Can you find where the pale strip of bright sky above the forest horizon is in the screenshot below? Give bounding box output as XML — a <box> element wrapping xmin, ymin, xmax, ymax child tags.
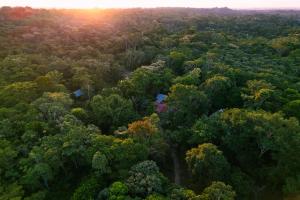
<box><xmin>0</xmin><ymin>0</ymin><xmax>300</xmax><ymax>9</ymax></box>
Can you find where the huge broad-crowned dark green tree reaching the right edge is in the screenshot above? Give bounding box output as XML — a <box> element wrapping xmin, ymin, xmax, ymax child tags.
<box><xmin>210</xmin><ymin>109</ymin><xmax>300</xmax><ymax>190</ymax></box>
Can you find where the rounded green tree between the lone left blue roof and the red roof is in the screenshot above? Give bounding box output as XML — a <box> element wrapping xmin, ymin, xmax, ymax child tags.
<box><xmin>91</xmin><ymin>94</ymin><xmax>136</xmax><ymax>130</ymax></box>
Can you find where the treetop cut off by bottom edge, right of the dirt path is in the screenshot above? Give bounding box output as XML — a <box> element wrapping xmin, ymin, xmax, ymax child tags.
<box><xmin>196</xmin><ymin>182</ymin><xmax>236</xmax><ymax>200</ymax></box>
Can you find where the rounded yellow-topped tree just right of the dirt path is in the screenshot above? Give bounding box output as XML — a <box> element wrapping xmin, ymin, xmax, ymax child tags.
<box><xmin>186</xmin><ymin>143</ymin><xmax>230</xmax><ymax>184</ymax></box>
